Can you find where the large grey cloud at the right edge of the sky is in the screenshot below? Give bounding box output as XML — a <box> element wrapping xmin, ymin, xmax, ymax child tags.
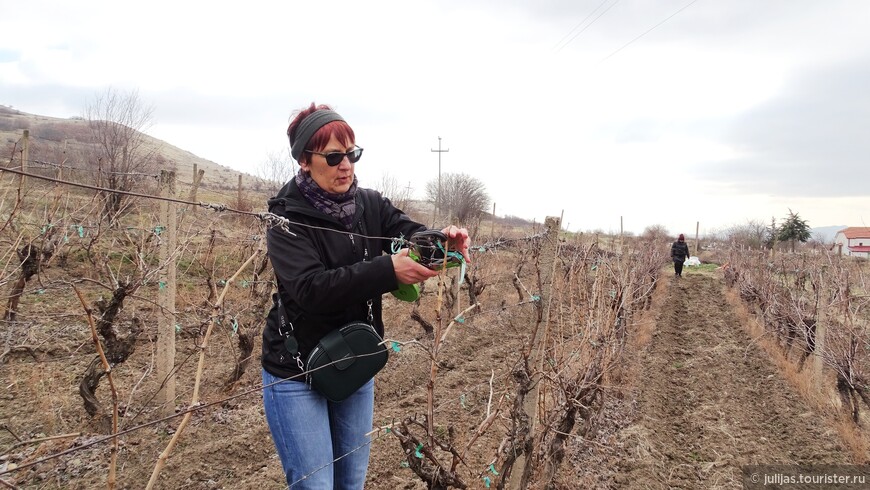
<box><xmin>696</xmin><ymin>56</ymin><xmax>870</xmax><ymax>197</ymax></box>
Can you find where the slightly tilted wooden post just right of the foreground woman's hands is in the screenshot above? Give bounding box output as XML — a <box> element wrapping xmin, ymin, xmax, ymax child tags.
<box><xmin>507</xmin><ymin>216</ymin><xmax>561</xmax><ymax>488</ymax></box>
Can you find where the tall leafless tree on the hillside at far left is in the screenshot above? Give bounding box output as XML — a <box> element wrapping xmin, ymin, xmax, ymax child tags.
<box><xmin>84</xmin><ymin>88</ymin><xmax>159</xmax><ymax>224</ymax></box>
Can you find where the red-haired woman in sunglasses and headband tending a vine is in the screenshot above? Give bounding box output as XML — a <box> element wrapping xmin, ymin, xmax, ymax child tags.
<box><xmin>262</xmin><ymin>103</ymin><xmax>469</xmax><ymax>489</ymax></box>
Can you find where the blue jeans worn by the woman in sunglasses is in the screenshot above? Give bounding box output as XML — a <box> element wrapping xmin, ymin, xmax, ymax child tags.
<box><xmin>263</xmin><ymin>369</ymin><xmax>375</xmax><ymax>490</ymax></box>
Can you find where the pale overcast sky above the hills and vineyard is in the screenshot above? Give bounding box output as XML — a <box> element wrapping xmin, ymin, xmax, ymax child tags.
<box><xmin>0</xmin><ymin>0</ymin><xmax>870</xmax><ymax>235</ymax></box>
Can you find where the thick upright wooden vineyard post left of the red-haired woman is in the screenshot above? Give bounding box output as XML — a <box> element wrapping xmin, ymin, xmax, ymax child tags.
<box><xmin>157</xmin><ymin>170</ymin><xmax>177</xmax><ymax>416</ymax></box>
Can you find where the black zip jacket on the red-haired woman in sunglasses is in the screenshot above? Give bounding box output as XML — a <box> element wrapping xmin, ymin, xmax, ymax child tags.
<box><xmin>262</xmin><ymin>179</ymin><xmax>426</xmax><ymax>381</ymax></box>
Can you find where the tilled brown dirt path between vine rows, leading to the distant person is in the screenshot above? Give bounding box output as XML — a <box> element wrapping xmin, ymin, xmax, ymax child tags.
<box><xmin>615</xmin><ymin>274</ymin><xmax>849</xmax><ymax>489</ymax></box>
